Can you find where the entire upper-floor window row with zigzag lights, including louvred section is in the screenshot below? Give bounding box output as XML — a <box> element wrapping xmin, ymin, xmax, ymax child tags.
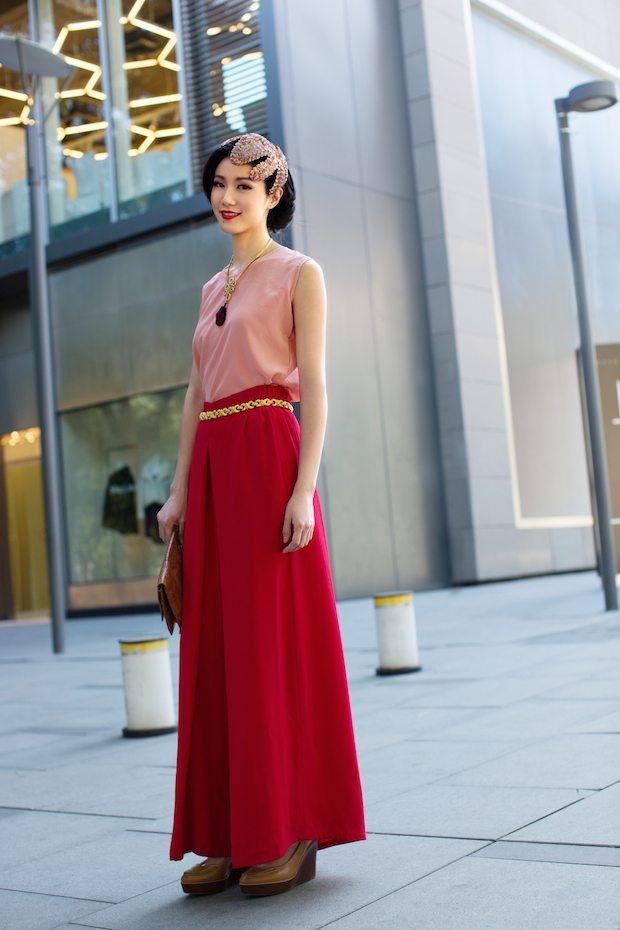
<box><xmin>0</xmin><ymin>0</ymin><xmax>268</xmax><ymax>257</ymax></box>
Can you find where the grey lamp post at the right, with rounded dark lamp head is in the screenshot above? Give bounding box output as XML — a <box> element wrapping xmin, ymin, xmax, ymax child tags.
<box><xmin>555</xmin><ymin>81</ymin><xmax>618</xmax><ymax>610</ymax></box>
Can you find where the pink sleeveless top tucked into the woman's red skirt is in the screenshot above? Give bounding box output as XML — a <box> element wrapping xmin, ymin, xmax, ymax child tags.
<box><xmin>192</xmin><ymin>246</ymin><xmax>308</xmax><ymax>401</ymax></box>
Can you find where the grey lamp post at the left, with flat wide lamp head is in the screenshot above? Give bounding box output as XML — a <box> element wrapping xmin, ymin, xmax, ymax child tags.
<box><xmin>0</xmin><ymin>35</ymin><xmax>73</xmax><ymax>652</ymax></box>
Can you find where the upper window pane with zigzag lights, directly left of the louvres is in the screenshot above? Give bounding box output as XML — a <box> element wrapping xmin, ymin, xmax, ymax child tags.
<box><xmin>106</xmin><ymin>0</ymin><xmax>188</xmax><ymax>217</ymax></box>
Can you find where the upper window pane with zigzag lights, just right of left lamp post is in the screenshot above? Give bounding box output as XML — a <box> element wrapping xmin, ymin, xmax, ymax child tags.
<box><xmin>38</xmin><ymin>0</ymin><xmax>110</xmax><ymax>239</ymax></box>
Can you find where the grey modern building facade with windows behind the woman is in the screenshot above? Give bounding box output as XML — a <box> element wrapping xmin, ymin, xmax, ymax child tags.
<box><xmin>0</xmin><ymin>0</ymin><xmax>620</xmax><ymax>616</ymax></box>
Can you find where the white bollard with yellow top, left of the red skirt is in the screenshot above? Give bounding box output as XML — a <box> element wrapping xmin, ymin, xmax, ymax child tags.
<box><xmin>119</xmin><ymin>637</ymin><xmax>177</xmax><ymax>736</ymax></box>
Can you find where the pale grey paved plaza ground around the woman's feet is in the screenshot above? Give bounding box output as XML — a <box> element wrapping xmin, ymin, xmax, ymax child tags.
<box><xmin>0</xmin><ymin>572</ymin><xmax>620</xmax><ymax>930</ymax></box>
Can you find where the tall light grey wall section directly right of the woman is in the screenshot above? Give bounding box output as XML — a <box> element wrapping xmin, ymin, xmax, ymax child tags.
<box><xmin>275</xmin><ymin>0</ymin><xmax>449</xmax><ymax>597</ymax></box>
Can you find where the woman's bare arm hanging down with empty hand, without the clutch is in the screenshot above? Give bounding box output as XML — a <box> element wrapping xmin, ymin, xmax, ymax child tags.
<box><xmin>282</xmin><ymin>260</ymin><xmax>327</xmax><ymax>552</ymax></box>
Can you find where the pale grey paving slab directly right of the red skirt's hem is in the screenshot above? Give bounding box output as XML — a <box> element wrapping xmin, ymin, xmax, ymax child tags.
<box><xmin>366</xmin><ymin>782</ymin><xmax>583</xmax><ymax>840</ymax></box>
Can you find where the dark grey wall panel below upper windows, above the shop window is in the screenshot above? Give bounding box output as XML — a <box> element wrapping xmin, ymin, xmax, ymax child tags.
<box><xmin>51</xmin><ymin>223</ymin><xmax>230</xmax><ymax>410</ymax></box>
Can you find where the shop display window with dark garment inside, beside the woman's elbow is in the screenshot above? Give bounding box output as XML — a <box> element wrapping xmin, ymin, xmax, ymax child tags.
<box><xmin>61</xmin><ymin>388</ymin><xmax>185</xmax><ymax>585</ymax></box>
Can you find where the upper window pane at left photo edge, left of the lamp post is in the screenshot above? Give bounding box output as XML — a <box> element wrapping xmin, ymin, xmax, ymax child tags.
<box><xmin>0</xmin><ymin>2</ymin><xmax>30</xmax><ymax>257</ymax></box>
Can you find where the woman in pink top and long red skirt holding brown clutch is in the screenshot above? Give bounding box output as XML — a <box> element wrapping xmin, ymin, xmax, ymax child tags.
<box><xmin>158</xmin><ymin>133</ymin><xmax>366</xmax><ymax>895</ymax></box>
